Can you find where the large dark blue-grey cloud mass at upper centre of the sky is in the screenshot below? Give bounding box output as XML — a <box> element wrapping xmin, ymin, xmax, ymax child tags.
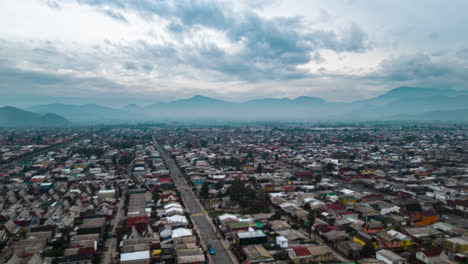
<box><xmin>75</xmin><ymin>0</ymin><xmax>369</xmax><ymax>81</ymax></box>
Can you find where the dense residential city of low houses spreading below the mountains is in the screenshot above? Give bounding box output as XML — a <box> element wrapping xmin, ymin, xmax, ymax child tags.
<box><xmin>0</xmin><ymin>123</ymin><xmax>468</xmax><ymax>264</ymax></box>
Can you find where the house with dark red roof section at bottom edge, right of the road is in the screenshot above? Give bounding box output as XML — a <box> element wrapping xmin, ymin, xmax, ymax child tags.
<box><xmin>287</xmin><ymin>246</ymin><xmax>334</xmax><ymax>264</ymax></box>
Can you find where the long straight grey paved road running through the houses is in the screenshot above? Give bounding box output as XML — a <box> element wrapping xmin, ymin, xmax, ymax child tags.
<box><xmin>153</xmin><ymin>138</ymin><xmax>232</xmax><ymax>264</ymax></box>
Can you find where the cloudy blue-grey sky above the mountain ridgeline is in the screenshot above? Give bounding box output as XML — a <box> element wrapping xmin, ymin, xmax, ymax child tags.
<box><xmin>0</xmin><ymin>0</ymin><xmax>468</xmax><ymax>106</ymax></box>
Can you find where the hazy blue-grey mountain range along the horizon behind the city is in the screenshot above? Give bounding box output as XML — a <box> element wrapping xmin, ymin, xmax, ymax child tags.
<box><xmin>0</xmin><ymin>87</ymin><xmax>468</xmax><ymax>126</ymax></box>
